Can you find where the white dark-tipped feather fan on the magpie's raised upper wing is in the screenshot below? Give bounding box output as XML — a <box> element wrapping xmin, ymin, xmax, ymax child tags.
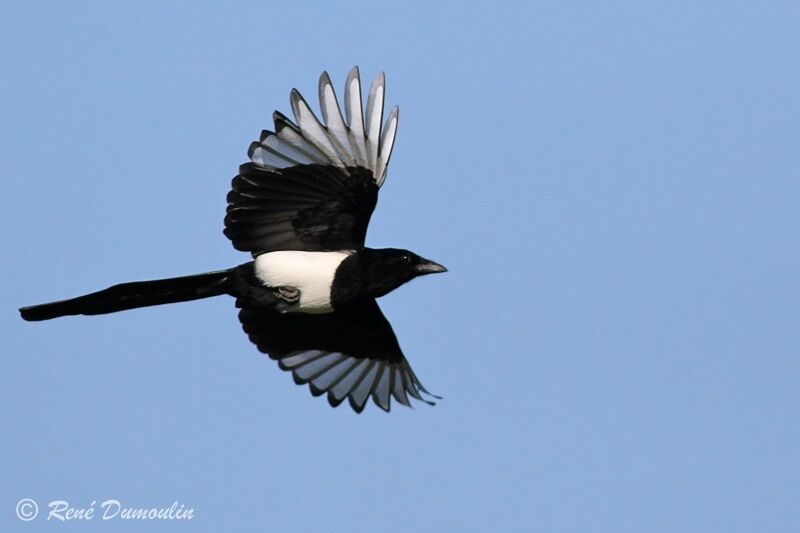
<box><xmin>248</xmin><ymin>67</ymin><xmax>399</xmax><ymax>187</ymax></box>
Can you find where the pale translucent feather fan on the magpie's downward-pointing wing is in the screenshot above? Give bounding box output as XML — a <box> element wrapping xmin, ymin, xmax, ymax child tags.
<box><xmin>278</xmin><ymin>350</ymin><xmax>440</xmax><ymax>413</ymax></box>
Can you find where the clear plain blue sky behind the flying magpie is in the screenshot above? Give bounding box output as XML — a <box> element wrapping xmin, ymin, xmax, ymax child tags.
<box><xmin>0</xmin><ymin>1</ymin><xmax>800</xmax><ymax>533</ymax></box>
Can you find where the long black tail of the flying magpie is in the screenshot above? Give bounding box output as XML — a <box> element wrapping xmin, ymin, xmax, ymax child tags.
<box><xmin>19</xmin><ymin>269</ymin><xmax>234</xmax><ymax>320</ymax></box>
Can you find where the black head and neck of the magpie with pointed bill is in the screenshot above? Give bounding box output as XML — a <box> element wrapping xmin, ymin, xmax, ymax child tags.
<box><xmin>357</xmin><ymin>248</ymin><xmax>447</xmax><ymax>298</ymax></box>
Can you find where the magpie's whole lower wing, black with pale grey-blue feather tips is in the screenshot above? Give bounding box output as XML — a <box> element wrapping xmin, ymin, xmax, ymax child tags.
<box><xmin>237</xmin><ymin>300</ymin><xmax>437</xmax><ymax>413</ymax></box>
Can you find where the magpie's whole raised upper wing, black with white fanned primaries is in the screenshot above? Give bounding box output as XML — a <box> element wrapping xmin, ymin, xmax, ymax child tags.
<box><xmin>225</xmin><ymin>68</ymin><xmax>398</xmax><ymax>255</ymax></box>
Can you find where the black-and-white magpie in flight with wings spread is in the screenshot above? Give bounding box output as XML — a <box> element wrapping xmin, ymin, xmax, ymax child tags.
<box><xmin>20</xmin><ymin>67</ymin><xmax>447</xmax><ymax>413</ymax></box>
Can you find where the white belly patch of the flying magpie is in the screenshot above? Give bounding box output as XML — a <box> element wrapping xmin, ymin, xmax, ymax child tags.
<box><xmin>255</xmin><ymin>250</ymin><xmax>350</xmax><ymax>313</ymax></box>
